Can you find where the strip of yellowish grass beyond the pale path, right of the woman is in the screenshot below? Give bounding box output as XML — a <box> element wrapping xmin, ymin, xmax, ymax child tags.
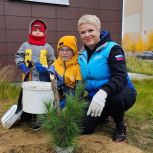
<box><xmin>126</xmin><ymin>57</ymin><xmax>153</xmax><ymax>75</ymax></box>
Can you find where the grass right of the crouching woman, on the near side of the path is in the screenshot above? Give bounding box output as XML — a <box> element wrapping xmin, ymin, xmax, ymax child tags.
<box><xmin>126</xmin><ymin>79</ymin><xmax>153</xmax><ymax>153</ymax></box>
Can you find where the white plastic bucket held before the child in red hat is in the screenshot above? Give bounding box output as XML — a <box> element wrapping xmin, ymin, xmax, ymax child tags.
<box><xmin>22</xmin><ymin>81</ymin><xmax>54</xmax><ymax>114</ymax></box>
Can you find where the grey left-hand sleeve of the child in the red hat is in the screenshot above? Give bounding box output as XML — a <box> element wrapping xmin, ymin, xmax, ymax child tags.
<box><xmin>15</xmin><ymin>43</ymin><xmax>25</xmax><ymax>66</ymax></box>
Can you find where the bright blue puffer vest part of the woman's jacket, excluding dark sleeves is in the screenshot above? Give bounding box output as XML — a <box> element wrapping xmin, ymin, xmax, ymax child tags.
<box><xmin>78</xmin><ymin>41</ymin><xmax>117</xmax><ymax>91</ymax></box>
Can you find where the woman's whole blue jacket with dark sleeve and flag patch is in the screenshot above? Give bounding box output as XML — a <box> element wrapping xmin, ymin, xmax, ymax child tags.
<box><xmin>78</xmin><ymin>29</ymin><xmax>135</xmax><ymax>96</ymax></box>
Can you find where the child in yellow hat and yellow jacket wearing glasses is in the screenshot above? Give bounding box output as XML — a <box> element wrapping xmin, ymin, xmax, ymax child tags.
<box><xmin>36</xmin><ymin>36</ymin><xmax>82</xmax><ymax>108</ymax></box>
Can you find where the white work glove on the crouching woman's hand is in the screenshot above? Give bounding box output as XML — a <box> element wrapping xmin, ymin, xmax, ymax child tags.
<box><xmin>87</xmin><ymin>89</ymin><xmax>107</xmax><ymax>117</ymax></box>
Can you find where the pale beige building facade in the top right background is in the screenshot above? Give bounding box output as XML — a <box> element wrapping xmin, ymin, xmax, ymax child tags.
<box><xmin>123</xmin><ymin>0</ymin><xmax>153</xmax><ymax>39</ymax></box>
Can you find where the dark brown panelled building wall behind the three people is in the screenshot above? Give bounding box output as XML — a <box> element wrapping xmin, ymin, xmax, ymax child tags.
<box><xmin>0</xmin><ymin>0</ymin><xmax>123</xmax><ymax>80</ymax></box>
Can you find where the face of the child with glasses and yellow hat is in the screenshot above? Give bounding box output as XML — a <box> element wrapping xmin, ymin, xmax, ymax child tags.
<box><xmin>58</xmin><ymin>46</ymin><xmax>74</xmax><ymax>61</ymax></box>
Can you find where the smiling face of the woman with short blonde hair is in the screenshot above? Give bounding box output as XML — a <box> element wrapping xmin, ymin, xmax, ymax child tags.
<box><xmin>79</xmin><ymin>24</ymin><xmax>100</xmax><ymax>49</ymax></box>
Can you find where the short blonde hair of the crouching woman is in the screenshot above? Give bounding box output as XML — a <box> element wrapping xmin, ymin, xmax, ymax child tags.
<box><xmin>78</xmin><ymin>14</ymin><xmax>101</xmax><ymax>30</ymax></box>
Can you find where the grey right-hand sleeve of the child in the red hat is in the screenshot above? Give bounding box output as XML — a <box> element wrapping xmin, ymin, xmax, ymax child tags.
<box><xmin>47</xmin><ymin>45</ymin><xmax>55</xmax><ymax>65</ymax></box>
